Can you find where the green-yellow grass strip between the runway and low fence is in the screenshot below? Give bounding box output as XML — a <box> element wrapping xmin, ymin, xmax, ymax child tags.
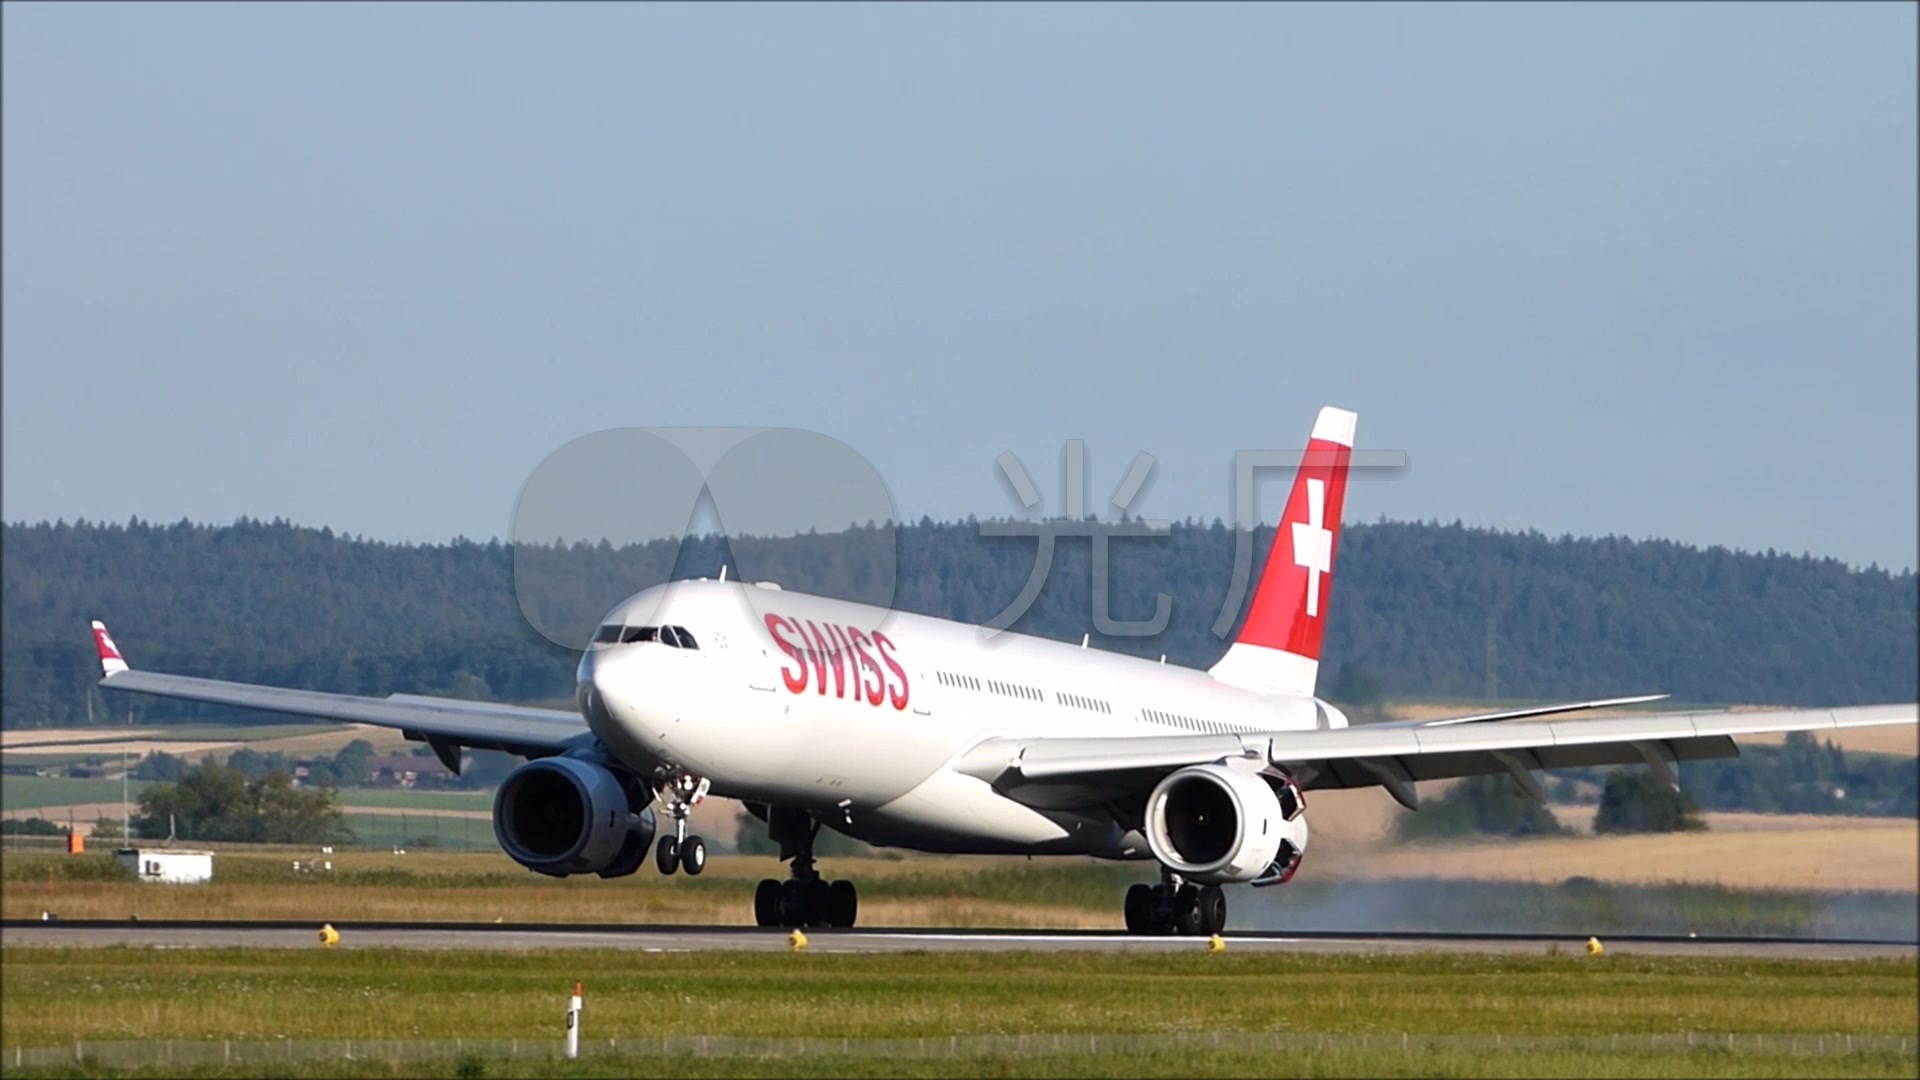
<box><xmin>0</xmin><ymin>945</ymin><xmax>1920</xmax><ymax>1076</ymax></box>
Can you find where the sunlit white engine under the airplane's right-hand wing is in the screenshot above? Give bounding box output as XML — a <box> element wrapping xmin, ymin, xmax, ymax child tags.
<box><xmin>1146</xmin><ymin>765</ymin><xmax>1308</xmax><ymax>884</ymax></box>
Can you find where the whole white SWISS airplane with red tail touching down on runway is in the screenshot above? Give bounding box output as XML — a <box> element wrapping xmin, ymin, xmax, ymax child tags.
<box><xmin>92</xmin><ymin>405</ymin><xmax>1916</xmax><ymax>936</ymax></box>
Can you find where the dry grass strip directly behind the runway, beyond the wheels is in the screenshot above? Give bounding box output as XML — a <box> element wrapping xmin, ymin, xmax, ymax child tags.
<box><xmin>0</xmin><ymin>849</ymin><xmax>1920</xmax><ymax>940</ymax></box>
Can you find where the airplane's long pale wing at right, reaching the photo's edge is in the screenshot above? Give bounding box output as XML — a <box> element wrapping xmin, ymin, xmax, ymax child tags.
<box><xmin>956</xmin><ymin>705</ymin><xmax>1920</xmax><ymax>809</ymax></box>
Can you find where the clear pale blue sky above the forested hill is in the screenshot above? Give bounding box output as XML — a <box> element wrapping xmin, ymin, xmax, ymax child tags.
<box><xmin>0</xmin><ymin>4</ymin><xmax>1920</xmax><ymax>567</ymax></box>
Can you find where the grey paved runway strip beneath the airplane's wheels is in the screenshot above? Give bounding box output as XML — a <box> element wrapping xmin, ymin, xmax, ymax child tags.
<box><xmin>0</xmin><ymin>919</ymin><xmax>1920</xmax><ymax>959</ymax></box>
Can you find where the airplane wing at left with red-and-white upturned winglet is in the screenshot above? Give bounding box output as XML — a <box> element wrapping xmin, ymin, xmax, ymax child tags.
<box><xmin>94</xmin><ymin>623</ymin><xmax>593</xmax><ymax>760</ymax></box>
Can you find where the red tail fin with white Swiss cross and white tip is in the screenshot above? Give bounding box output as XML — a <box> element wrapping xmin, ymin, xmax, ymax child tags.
<box><xmin>1213</xmin><ymin>405</ymin><xmax>1359</xmax><ymax>694</ymax></box>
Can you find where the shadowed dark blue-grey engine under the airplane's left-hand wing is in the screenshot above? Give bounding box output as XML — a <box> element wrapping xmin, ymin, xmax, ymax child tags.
<box><xmin>493</xmin><ymin>757</ymin><xmax>655</xmax><ymax>878</ymax></box>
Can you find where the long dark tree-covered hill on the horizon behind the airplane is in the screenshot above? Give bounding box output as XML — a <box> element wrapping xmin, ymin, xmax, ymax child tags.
<box><xmin>0</xmin><ymin>519</ymin><xmax>1920</xmax><ymax>726</ymax></box>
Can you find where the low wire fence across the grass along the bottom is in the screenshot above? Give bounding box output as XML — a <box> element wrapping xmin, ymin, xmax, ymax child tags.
<box><xmin>0</xmin><ymin>1032</ymin><xmax>1920</xmax><ymax>1070</ymax></box>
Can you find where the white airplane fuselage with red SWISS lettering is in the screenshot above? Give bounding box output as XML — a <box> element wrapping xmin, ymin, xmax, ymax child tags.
<box><xmin>578</xmin><ymin>580</ymin><xmax>1346</xmax><ymax>859</ymax></box>
